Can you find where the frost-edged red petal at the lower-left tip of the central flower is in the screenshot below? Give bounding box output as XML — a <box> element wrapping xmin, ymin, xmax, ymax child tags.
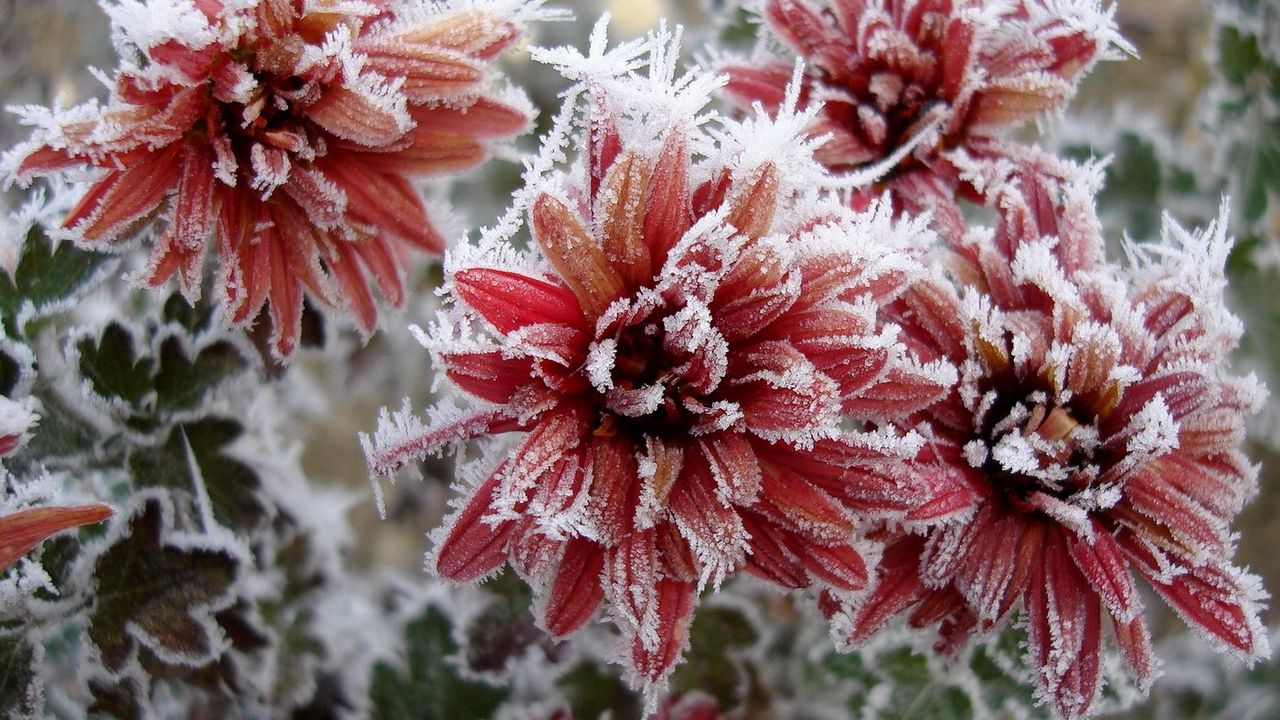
<box><xmin>435</xmin><ymin>465</ymin><xmax>516</xmax><ymax>583</ymax></box>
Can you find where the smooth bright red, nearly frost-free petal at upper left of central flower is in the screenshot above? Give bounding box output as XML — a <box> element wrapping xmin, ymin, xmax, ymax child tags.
<box><xmin>453</xmin><ymin>268</ymin><xmax>582</xmax><ymax>334</ymax></box>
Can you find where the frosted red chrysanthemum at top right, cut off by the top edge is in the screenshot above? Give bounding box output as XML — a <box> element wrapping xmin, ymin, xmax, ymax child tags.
<box><xmin>724</xmin><ymin>0</ymin><xmax>1128</xmax><ymax>229</ymax></box>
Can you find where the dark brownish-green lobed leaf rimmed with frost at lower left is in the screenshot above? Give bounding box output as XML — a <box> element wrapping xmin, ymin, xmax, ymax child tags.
<box><xmin>88</xmin><ymin>500</ymin><xmax>238</xmax><ymax>671</ymax></box>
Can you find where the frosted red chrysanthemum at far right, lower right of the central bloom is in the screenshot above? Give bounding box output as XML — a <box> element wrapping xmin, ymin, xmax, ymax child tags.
<box><xmin>828</xmin><ymin>166</ymin><xmax>1268</xmax><ymax>717</ymax></box>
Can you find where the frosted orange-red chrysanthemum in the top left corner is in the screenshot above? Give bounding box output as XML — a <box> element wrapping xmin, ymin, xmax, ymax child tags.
<box><xmin>5</xmin><ymin>0</ymin><xmax>537</xmax><ymax>356</ymax></box>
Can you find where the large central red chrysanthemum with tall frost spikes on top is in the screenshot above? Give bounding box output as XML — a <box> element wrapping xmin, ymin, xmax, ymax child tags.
<box><xmin>366</xmin><ymin>25</ymin><xmax>954</xmax><ymax>703</ymax></box>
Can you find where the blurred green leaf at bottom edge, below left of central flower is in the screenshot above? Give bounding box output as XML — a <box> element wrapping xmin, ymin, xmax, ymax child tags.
<box><xmin>370</xmin><ymin>606</ymin><xmax>509</xmax><ymax>720</ymax></box>
